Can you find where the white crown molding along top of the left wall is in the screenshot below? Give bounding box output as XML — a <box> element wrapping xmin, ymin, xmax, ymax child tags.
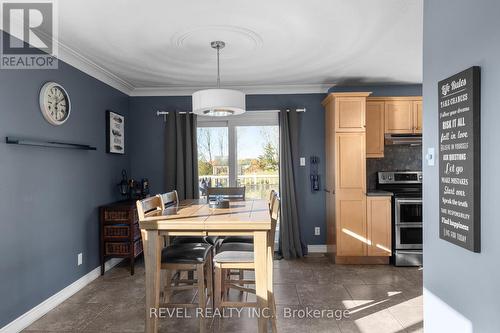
<box><xmin>57</xmin><ymin>42</ymin><xmax>134</xmax><ymax>96</ymax></box>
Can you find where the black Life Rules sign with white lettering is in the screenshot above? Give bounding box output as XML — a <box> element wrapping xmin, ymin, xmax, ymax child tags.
<box><xmin>438</xmin><ymin>66</ymin><xmax>481</xmax><ymax>252</ymax></box>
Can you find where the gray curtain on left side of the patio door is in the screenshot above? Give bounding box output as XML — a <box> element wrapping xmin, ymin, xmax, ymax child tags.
<box><xmin>165</xmin><ymin>112</ymin><xmax>199</xmax><ymax>200</ymax></box>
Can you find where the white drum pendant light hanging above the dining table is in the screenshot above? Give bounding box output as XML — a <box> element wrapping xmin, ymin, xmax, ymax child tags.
<box><xmin>193</xmin><ymin>41</ymin><xmax>245</xmax><ymax>117</ymax></box>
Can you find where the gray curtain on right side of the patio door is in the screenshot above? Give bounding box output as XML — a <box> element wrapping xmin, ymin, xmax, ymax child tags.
<box><xmin>279</xmin><ymin>110</ymin><xmax>307</xmax><ymax>259</ymax></box>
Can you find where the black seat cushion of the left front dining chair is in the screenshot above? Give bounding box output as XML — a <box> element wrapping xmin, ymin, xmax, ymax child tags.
<box><xmin>161</xmin><ymin>243</ymin><xmax>212</xmax><ymax>264</ymax></box>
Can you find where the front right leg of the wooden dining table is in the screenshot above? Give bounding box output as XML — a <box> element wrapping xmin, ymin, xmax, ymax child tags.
<box><xmin>254</xmin><ymin>231</ymin><xmax>270</xmax><ymax>333</ymax></box>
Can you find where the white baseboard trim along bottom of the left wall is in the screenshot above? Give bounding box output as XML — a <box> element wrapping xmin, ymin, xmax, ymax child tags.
<box><xmin>0</xmin><ymin>258</ymin><xmax>123</xmax><ymax>333</ymax></box>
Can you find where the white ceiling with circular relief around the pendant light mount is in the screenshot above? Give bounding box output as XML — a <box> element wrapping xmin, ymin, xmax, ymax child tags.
<box><xmin>53</xmin><ymin>0</ymin><xmax>423</xmax><ymax>95</ymax></box>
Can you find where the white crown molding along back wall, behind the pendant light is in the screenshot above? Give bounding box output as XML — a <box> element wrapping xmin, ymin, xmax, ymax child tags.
<box><xmin>130</xmin><ymin>83</ymin><xmax>335</xmax><ymax>96</ymax></box>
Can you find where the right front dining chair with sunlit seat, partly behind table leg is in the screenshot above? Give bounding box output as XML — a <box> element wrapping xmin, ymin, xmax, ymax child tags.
<box><xmin>213</xmin><ymin>194</ymin><xmax>280</xmax><ymax>332</ymax></box>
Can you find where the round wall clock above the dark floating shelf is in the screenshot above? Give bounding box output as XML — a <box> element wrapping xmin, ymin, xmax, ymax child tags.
<box><xmin>40</xmin><ymin>82</ymin><xmax>71</xmax><ymax>126</ymax></box>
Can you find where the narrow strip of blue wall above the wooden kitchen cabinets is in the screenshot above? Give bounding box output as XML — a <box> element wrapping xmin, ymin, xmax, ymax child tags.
<box><xmin>328</xmin><ymin>84</ymin><xmax>422</xmax><ymax>96</ymax></box>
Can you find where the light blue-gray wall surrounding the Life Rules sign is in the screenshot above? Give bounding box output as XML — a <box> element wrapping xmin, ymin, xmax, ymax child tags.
<box><xmin>423</xmin><ymin>0</ymin><xmax>500</xmax><ymax>333</ymax></box>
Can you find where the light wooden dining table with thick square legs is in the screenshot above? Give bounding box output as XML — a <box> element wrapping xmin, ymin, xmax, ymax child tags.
<box><xmin>139</xmin><ymin>199</ymin><xmax>273</xmax><ymax>333</ymax></box>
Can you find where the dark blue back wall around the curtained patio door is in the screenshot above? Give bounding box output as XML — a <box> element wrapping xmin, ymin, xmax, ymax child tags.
<box><xmin>129</xmin><ymin>94</ymin><xmax>326</xmax><ymax>244</ymax></box>
